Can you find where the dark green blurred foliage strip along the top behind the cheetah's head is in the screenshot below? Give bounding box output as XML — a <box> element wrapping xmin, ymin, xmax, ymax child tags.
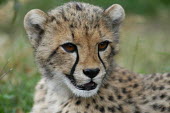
<box><xmin>18</xmin><ymin>0</ymin><xmax>170</xmax><ymax>15</ymax></box>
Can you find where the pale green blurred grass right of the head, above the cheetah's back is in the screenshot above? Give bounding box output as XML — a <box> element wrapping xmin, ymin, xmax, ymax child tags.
<box><xmin>118</xmin><ymin>17</ymin><xmax>170</xmax><ymax>73</ymax></box>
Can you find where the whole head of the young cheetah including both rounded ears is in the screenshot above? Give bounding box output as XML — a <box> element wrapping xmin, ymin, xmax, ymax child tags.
<box><xmin>24</xmin><ymin>2</ymin><xmax>124</xmax><ymax>97</ymax></box>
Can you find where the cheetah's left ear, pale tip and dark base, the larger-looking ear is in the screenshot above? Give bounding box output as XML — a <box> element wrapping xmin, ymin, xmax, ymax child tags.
<box><xmin>24</xmin><ymin>9</ymin><xmax>48</xmax><ymax>48</ymax></box>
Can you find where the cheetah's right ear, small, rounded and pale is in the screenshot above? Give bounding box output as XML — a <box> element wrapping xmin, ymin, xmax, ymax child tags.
<box><xmin>104</xmin><ymin>4</ymin><xmax>125</xmax><ymax>24</ymax></box>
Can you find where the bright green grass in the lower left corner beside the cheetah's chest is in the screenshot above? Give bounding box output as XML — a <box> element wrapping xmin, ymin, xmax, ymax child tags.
<box><xmin>0</xmin><ymin>73</ymin><xmax>39</xmax><ymax>113</ymax></box>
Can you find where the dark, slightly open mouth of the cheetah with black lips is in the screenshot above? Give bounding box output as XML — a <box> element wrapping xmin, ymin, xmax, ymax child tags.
<box><xmin>66</xmin><ymin>75</ymin><xmax>97</xmax><ymax>91</ymax></box>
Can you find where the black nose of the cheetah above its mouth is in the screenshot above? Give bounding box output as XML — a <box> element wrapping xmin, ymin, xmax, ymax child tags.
<box><xmin>83</xmin><ymin>68</ymin><xmax>100</xmax><ymax>78</ymax></box>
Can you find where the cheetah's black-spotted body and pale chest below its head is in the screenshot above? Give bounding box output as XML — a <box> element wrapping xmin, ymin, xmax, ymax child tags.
<box><xmin>33</xmin><ymin>67</ymin><xmax>170</xmax><ymax>113</ymax></box>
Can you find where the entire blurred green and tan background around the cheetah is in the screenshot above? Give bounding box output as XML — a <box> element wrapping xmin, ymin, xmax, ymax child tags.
<box><xmin>0</xmin><ymin>0</ymin><xmax>170</xmax><ymax>113</ymax></box>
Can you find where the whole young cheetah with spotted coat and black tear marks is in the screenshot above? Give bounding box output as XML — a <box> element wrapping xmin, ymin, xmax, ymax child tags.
<box><xmin>24</xmin><ymin>2</ymin><xmax>170</xmax><ymax>113</ymax></box>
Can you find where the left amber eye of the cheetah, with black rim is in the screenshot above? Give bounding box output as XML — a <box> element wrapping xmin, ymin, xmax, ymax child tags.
<box><xmin>62</xmin><ymin>43</ymin><xmax>77</xmax><ymax>53</ymax></box>
